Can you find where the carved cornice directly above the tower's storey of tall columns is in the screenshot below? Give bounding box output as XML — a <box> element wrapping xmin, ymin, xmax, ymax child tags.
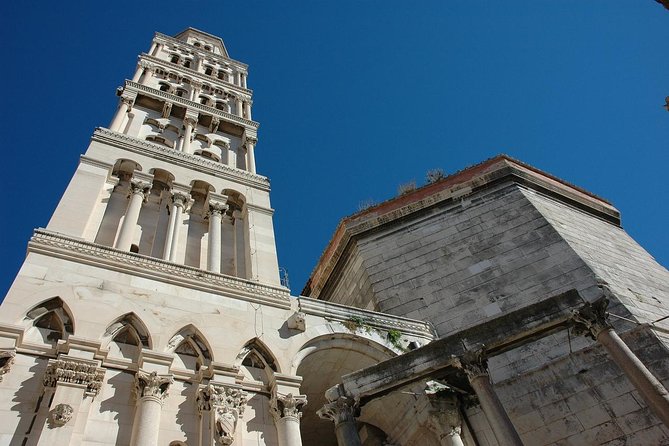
<box><xmin>92</xmin><ymin>127</ymin><xmax>269</xmax><ymax>191</ymax></box>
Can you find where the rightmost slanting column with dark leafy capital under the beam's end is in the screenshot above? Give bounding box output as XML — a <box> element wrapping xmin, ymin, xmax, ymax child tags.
<box><xmin>574</xmin><ymin>298</ymin><xmax>669</xmax><ymax>427</ymax></box>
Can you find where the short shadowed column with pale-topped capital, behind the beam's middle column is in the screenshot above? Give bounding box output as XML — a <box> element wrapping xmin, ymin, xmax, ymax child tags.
<box><xmin>425</xmin><ymin>381</ymin><xmax>464</xmax><ymax>446</ymax></box>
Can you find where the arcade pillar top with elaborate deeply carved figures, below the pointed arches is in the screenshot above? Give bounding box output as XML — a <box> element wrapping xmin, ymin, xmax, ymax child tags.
<box><xmin>197</xmin><ymin>382</ymin><xmax>248</xmax><ymax>445</ymax></box>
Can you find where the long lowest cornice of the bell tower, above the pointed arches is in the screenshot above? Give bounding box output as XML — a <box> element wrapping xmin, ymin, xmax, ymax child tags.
<box><xmin>28</xmin><ymin>229</ymin><xmax>290</xmax><ymax>309</ymax></box>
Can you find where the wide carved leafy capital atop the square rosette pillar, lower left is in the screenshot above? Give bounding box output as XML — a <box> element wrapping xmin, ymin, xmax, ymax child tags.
<box><xmin>43</xmin><ymin>359</ymin><xmax>105</xmax><ymax>396</ymax></box>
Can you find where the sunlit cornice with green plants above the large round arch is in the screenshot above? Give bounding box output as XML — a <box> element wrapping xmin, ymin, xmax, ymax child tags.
<box><xmin>298</xmin><ymin>296</ymin><xmax>436</xmax><ymax>340</ymax></box>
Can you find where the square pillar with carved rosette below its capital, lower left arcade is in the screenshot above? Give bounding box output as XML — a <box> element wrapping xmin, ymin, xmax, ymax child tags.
<box><xmin>35</xmin><ymin>355</ymin><xmax>105</xmax><ymax>446</ymax></box>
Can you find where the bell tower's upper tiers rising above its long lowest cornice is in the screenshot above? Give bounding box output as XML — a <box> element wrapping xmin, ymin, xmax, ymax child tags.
<box><xmin>47</xmin><ymin>28</ymin><xmax>279</xmax><ymax>285</ymax></box>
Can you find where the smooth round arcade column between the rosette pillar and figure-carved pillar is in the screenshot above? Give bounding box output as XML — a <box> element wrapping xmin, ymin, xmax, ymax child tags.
<box><xmin>130</xmin><ymin>370</ymin><xmax>174</xmax><ymax>446</ymax></box>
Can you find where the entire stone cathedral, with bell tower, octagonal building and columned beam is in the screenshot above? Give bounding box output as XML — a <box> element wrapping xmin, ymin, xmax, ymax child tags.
<box><xmin>0</xmin><ymin>28</ymin><xmax>669</xmax><ymax>446</ymax></box>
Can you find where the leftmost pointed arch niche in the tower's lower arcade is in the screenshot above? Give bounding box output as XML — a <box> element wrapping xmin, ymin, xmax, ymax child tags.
<box><xmin>22</xmin><ymin>296</ymin><xmax>74</xmax><ymax>344</ymax></box>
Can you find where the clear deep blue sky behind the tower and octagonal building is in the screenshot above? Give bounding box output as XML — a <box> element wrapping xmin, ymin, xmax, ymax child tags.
<box><xmin>0</xmin><ymin>0</ymin><xmax>669</xmax><ymax>295</ymax></box>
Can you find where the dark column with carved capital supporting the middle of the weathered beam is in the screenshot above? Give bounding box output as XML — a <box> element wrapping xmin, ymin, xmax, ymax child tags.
<box><xmin>460</xmin><ymin>348</ymin><xmax>523</xmax><ymax>446</ymax></box>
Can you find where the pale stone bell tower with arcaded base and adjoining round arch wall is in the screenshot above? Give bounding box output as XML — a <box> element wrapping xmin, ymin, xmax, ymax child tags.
<box><xmin>0</xmin><ymin>29</ymin><xmax>434</xmax><ymax>446</ymax></box>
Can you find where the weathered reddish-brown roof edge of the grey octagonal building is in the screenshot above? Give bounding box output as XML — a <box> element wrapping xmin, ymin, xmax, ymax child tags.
<box><xmin>302</xmin><ymin>154</ymin><xmax>620</xmax><ymax>298</ymax></box>
